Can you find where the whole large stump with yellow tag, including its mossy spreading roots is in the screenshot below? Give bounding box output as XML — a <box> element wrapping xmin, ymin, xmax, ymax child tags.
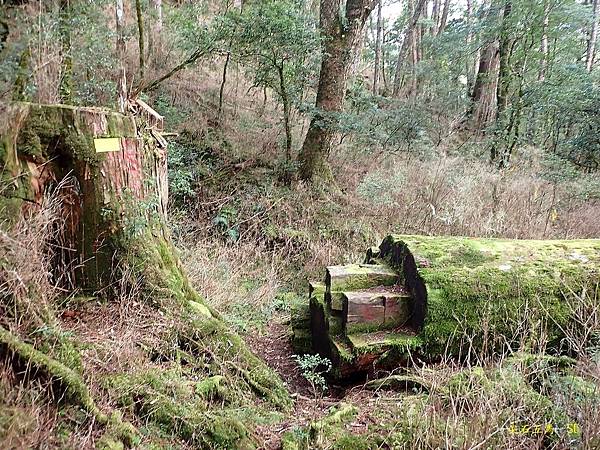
<box><xmin>0</xmin><ymin>103</ymin><xmax>290</xmax><ymax>449</ymax></box>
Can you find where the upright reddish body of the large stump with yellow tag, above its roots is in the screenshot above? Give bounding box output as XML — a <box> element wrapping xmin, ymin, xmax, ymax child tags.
<box><xmin>0</xmin><ymin>103</ymin><xmax>168</xmax><ymax>290</ymax></box>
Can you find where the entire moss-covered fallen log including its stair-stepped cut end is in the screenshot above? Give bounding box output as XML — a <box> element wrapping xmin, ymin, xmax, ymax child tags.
<box><xmin>292</xmin><ymin>235</ymin><xmax>600</xmax><ymax>378</ymax></box>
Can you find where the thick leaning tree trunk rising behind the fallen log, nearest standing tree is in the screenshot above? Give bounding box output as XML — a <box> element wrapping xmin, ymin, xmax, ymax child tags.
<box><xmin>298</xmin><ymin>0</ymin><xmax>376</xmax><ymax>181</ymax></box>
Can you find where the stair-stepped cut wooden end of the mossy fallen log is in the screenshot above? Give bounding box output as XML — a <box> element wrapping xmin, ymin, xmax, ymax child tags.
<box><xmin>302</xmin><ymin>263</ymin><xmax>418</xmax><ymax>378</ymax></box>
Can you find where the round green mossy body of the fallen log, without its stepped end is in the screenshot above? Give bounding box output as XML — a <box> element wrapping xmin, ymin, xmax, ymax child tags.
<box><xmin>376</xmin><ymin>235</ymin><xmax>600</xmax><ymax>355</ymax></box>
